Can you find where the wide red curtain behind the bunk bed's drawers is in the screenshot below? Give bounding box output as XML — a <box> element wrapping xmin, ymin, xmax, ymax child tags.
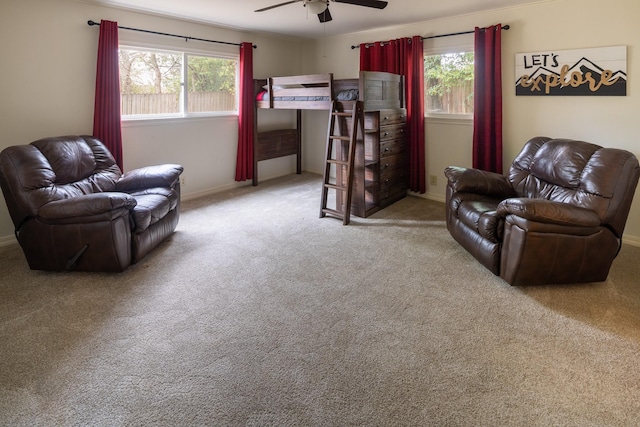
<box><xmin>360</xmin><ymin>36</ymin><xmax>427</xmax><ymax>193</ymax></box>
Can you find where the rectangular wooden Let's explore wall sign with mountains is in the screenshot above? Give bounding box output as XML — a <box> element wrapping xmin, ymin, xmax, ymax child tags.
<box><xmin>516</xmin><ymin>46</ymin><xmax>627</xmax><ymax>96</ymax></box>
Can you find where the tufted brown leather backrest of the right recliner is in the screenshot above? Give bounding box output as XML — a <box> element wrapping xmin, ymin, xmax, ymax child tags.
<box><xmin>508</xmin><ymin>137</ymin><xmax>640</xmax><ymax>236</ymax></box>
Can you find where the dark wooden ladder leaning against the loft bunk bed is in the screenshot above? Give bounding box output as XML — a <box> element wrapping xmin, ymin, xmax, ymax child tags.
<box><xmin>320</xmin><ymin>101</ymin><xmax>364</xmax><ymax>225</ymax></box>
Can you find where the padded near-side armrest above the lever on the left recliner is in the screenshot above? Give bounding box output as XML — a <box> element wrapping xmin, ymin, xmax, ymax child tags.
<box><xmin>38</xmin><ymin>192</ymin><xmax>136</xmax><ymax>220</ymax></box>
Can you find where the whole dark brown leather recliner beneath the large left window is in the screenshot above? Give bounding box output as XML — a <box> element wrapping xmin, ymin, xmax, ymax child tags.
<box><xmin>0</xmin><ymin>136</ymin><xmax>183</xmax><ymax>271</ymax></box>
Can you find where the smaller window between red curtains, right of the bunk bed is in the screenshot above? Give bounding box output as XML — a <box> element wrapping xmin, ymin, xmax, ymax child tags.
<box><xmin>424</xmin><ymin>52</ymin><xmax>473</xmax><ymax>116</ymax></box>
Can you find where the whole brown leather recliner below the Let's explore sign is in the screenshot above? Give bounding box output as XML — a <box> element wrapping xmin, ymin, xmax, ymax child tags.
<box><xmin>445</xmin><ymin>137</ymin><xmax>640</xmax><ymax>285</ymax></box>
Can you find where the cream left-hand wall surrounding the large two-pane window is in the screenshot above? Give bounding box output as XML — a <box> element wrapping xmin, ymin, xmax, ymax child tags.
<box><xmin>0</xmin><ymin>0</ymin><xmax>302</xmax><ymax>244</ymax></box>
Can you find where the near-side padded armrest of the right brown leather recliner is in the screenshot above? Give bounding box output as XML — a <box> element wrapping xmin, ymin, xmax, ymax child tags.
<box><xmin>497</xmin><ymin>198</ymin><xmax>601</xmax><ymax>227</ymax></box>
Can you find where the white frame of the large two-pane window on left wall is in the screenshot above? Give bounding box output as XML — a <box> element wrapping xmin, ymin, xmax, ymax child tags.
<box><xmin>118</xmin><ymin>42</ymin><xmax>240</xmax><ymax>122</ymax></box>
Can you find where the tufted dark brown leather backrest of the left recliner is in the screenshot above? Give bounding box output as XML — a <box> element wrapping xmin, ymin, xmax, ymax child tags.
<box><xmin>0</xmin><ymin>136</ymin><xmax>122</xmax><ymax>231</ymax></box>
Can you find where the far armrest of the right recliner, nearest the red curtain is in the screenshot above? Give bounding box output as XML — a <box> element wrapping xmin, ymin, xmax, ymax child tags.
<box><xmin>444</xmin><ymin>166</ymin><xmax>516</xmax><ymax>198</ymax></box>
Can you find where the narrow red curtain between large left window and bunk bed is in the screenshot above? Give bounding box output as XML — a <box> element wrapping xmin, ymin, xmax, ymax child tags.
<box><xmin>236</xmin><ymin>43</ymin><xmax>255</xmax><ymax>181</ymax></box>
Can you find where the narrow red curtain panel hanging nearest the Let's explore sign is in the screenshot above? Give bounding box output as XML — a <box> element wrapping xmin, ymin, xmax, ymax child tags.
<box><xmin>473</xmin><ymin>24</ymin><xmax>502</xmax><ymax>173</ymax></box>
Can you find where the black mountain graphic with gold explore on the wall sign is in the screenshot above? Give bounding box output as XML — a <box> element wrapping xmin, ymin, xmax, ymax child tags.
<box><xmin>516</xmin><ymin>57</ymin><xmax>627</xmax><ymax>96</ymax></box>
